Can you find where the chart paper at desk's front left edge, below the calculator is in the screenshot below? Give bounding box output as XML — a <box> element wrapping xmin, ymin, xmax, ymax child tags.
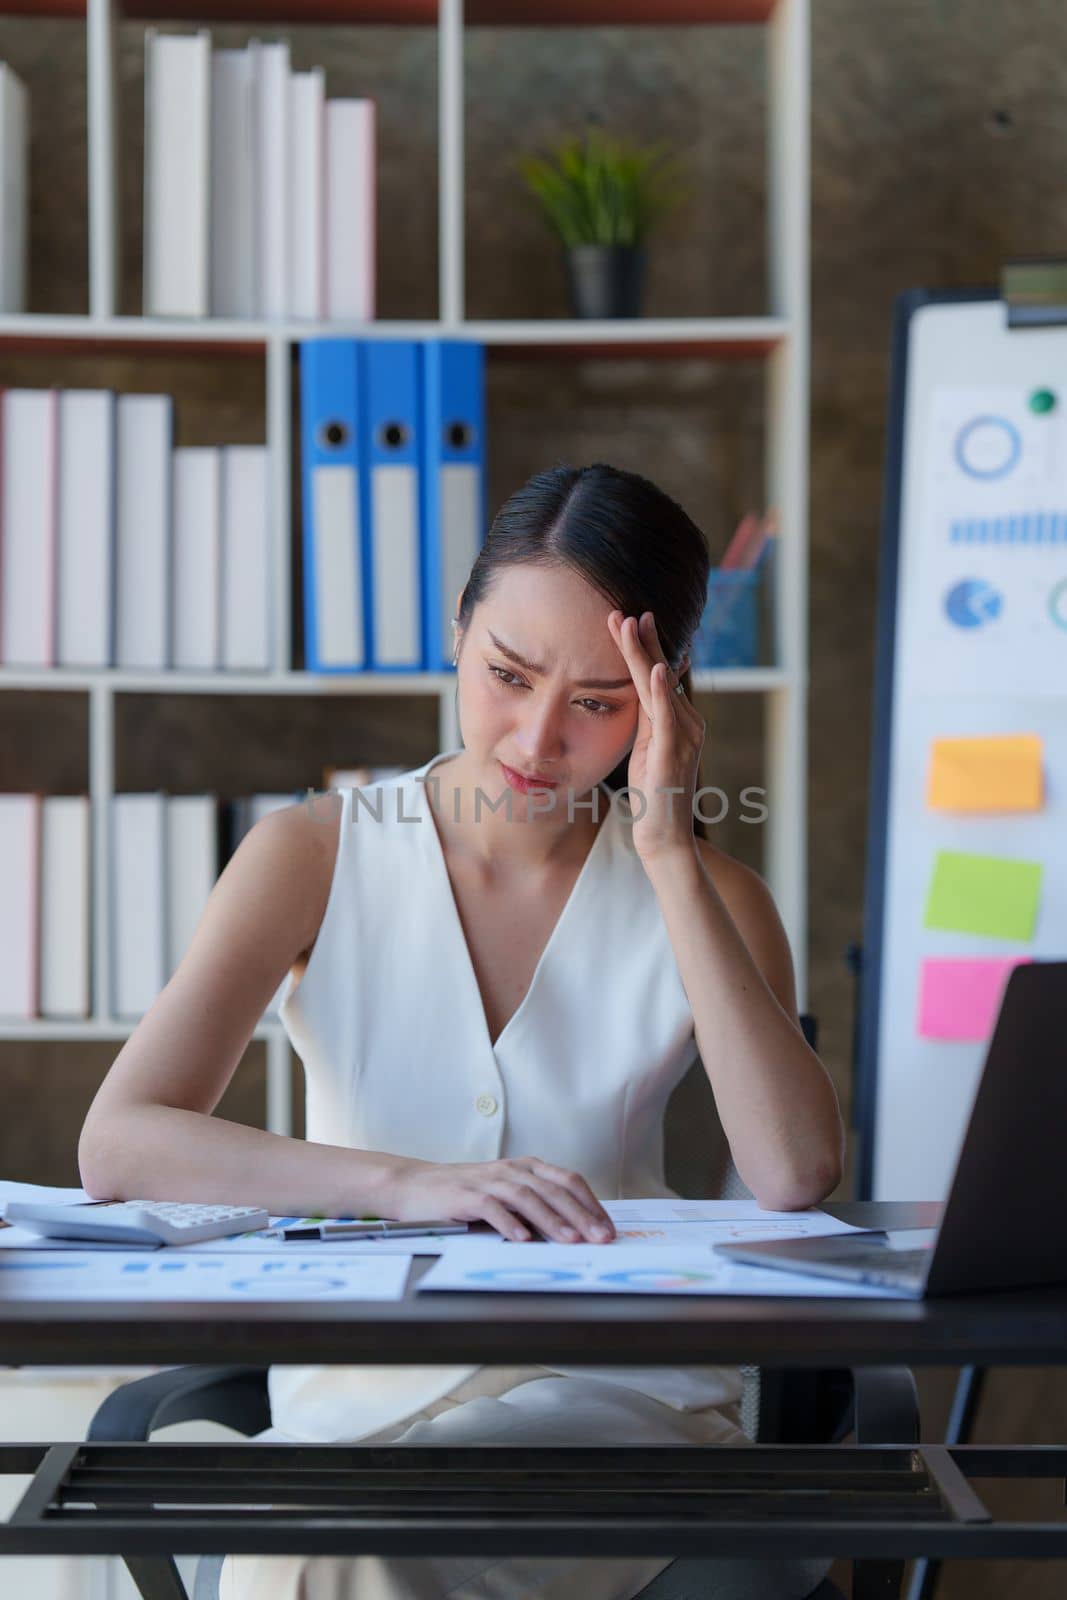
<box><xmin>0</xmin><ymin>1245</ymin><xmax>411</xmax><ymax>1306</ymax></box>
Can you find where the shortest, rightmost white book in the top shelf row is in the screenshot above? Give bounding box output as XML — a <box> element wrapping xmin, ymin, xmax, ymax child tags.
<box><xmin>326</xmin><ymin>99</ymin><xmax>378</xmax><ymax>322</ymax></box>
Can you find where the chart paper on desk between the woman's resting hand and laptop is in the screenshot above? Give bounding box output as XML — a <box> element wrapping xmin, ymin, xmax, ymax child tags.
<box><xmin>418</xmin><ymin>1238</ymin><xmax>893</xmax><ymax>1299</ymax></box>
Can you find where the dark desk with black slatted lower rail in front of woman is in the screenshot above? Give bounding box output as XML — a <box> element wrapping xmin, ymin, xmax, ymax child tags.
<box><xmin>0</xmin><ymin>1203</ymin><xmax>1067</xmax><ymax>1595</ymax></box>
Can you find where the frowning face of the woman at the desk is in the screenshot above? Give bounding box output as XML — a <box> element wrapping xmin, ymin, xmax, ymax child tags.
<box><xmin>458</xmin><ymin>566</ymin><xmax>638</xmax><ymax>811</ymax></box>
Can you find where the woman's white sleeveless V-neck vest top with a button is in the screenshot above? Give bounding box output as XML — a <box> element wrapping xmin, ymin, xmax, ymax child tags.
<box><xmin>269</xmin><ymin>750</ymin><xmax>741</xmax><ymax>1440</ymax></box>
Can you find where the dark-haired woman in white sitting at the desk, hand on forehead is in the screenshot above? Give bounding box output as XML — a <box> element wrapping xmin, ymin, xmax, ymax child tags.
<box><xmin>80</xmin><ymin>464</ymin><xmax>843</xmax><ymax>1600</ymax></box>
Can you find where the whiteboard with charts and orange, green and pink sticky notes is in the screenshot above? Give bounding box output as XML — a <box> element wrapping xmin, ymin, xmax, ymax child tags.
<box><xmin>854</xmin><ymin>290</ymin><xmax>1067</xmax><ymax>1200</ymax></box>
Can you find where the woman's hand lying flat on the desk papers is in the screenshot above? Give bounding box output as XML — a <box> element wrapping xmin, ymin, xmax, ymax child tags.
<box><xmin>387</xmin><ymin>1155</ymin><xmax>614</xmax><ymax>1245</ymax></box>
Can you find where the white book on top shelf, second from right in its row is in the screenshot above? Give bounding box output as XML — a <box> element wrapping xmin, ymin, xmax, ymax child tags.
<box><xmin>290</xmin><ymin>67</ymin><xmax>326</xmax><ymax>322</ymax></box>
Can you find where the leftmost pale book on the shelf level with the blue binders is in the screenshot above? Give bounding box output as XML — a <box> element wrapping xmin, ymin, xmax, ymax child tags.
<box><xmin>0</xmin><ymin>389</ymin><xmax>59</xmax><ymax>667</ymax></box>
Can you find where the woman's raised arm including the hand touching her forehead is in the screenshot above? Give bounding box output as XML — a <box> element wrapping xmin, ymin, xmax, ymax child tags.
<box><xmin>608</xmin><ymin>611</ymin><xmax>845</xmax><ymax>1211</ymax></box>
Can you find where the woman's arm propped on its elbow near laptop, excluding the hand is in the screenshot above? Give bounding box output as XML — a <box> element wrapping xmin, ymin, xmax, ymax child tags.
<box><xmin>646</xmin><ymin>838</ymin><xmax>845</xmax><ymax>1211</ymax></box>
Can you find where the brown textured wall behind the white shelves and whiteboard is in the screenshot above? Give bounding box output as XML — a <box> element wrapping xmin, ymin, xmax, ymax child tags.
<box><xmin>0</xmin><ymin>9</ymin><xmax>1067</xmax><ymax>1597</ymax></box>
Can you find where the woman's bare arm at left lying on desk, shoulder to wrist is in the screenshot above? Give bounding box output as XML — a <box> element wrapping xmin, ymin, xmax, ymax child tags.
<box><xmin>78</xmin><ymin>797</ymin><xmax>408</xmax><ymax>1216</ymax></box>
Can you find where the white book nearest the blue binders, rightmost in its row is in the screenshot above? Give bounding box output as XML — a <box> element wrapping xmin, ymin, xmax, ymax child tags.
<box><xmin>221</xmin><ymin>445</ymin><xmax>270</xmax><ymax>672</ymax></box>
